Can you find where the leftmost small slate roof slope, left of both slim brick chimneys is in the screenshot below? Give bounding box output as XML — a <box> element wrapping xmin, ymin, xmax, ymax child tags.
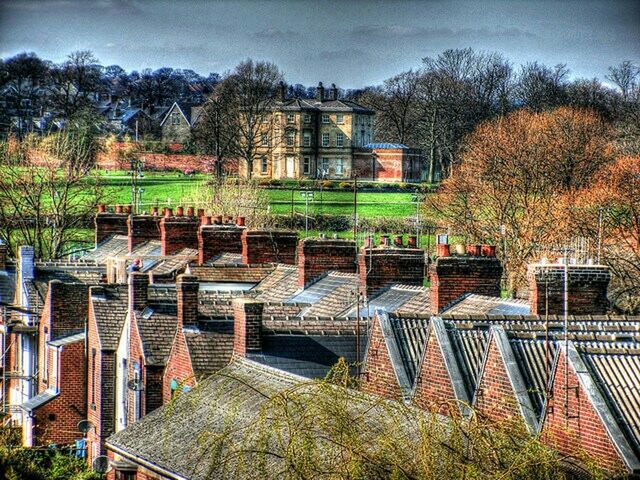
<box><xmin>90</xmin><ymin>285</ymin><xmax>129</xmax><ymax>351</ymax></box>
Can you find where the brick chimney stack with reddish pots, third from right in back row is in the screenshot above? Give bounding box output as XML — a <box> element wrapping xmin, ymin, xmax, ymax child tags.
<box><xmin>358</xmin><ymin>242</ymin><xmax>425</xmax><ymax>296</ymax></box>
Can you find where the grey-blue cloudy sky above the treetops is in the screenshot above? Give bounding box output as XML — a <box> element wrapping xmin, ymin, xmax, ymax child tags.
<box><xmin>0</xmin><ymin>0</ymin><xmax>640</xmax><ymax>88</ymax></box>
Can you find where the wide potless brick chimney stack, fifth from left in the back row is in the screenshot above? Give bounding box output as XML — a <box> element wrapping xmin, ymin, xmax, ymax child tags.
<box><xmin>242</xmin><ymin>230</ymin><xmax>298</xmax><ymax>265</ymax></box>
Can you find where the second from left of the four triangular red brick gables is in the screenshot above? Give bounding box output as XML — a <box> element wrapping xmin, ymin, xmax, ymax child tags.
<box><xmin>412</xmin><ymin>330</ymin><xmax>459</xmax><ymax>415</ymax></box>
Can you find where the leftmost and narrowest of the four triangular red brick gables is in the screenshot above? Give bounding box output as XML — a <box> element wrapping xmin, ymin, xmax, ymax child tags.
<box><xmin>362</xmin><ymin>316</ymin><xmax>402</xmax><ymax>400</ymax></box>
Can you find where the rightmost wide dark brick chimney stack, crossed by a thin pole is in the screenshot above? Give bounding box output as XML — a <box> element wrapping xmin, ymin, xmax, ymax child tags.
<box><xmin>527</xmin><ymin>263</ymin><xmax>611</xmax><ymax>315</ymax></box>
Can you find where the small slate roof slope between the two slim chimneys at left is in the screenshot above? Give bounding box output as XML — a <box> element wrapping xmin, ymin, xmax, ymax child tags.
<box><xmin>135</xmin><ymin>305</ymin><xmax>178</xmax><ymax>366</ymax></box>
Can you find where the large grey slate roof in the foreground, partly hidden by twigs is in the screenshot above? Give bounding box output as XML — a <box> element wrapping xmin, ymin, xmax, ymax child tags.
<box><xmin>107</xmin><ymin>359</ymin><xmax>419</xmax><ymax>480</ymax></box>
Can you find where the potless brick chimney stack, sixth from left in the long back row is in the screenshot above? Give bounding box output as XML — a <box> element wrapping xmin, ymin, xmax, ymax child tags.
<box><xmin>298</xmin><ymin>238</ymin><xmax>356</xmax><ymax>288</ymax></box>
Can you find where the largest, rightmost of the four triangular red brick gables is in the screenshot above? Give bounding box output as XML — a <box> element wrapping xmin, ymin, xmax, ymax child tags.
<box><xmin>542</xmin><ymin>352</ymin><xmax>624</xmax><ymax>470</ymax></box>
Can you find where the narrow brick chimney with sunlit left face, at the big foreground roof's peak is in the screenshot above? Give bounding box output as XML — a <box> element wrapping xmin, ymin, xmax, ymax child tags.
<box><xmin>233</xmin><ymin>298</ymin><xmax>264</xmax><ymax>356</ymax></box>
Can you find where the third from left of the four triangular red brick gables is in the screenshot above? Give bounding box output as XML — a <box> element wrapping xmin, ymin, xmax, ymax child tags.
<box><xmin>474</xmin><ymin>339</ymin><xmax>525</xmax><ymax>428</ymax></box>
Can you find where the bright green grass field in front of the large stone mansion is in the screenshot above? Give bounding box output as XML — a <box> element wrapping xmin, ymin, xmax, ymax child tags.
<box><xmin>96</xmin><ymin>172</ymin><xmax>416</xmax><ymax>217</ymax></box>
